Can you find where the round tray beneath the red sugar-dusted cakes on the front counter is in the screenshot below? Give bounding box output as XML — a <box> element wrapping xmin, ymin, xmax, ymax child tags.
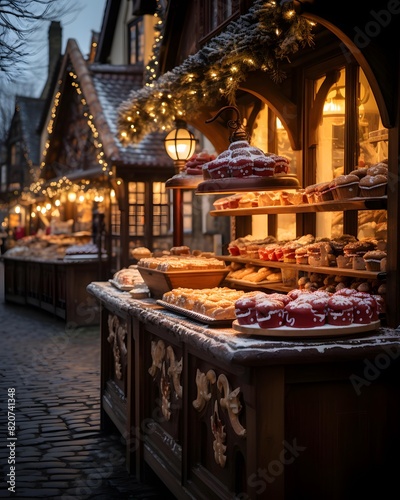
<box><xmin>232</xmin><ymin>319</ymin><xmax>381</xmax><ymax>339</ymax></box>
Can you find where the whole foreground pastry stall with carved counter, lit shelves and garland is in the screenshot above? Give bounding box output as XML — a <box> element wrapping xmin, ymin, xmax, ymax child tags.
<box><xmin>88</xmin><ymin>0</ymin><xmax>400</xmax><ymax>500</ymax></box>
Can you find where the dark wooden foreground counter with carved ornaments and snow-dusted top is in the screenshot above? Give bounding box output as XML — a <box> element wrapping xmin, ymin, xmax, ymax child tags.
<box><xmin>88</xmin><ymin>282</ymin><xmax>400</xmax><ymax>500</ymax></box>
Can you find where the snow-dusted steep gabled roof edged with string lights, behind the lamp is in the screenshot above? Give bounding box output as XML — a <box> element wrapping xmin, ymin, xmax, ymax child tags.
<box><xmin>42</xmin><ymin>39</ymin><xmax>173</xmax><ymax>180</ymax></box>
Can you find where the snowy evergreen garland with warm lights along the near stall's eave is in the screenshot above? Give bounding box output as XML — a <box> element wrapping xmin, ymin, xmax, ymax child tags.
<box><xmin>118</xmin><ymin>0</ymin><xmax>313</xmax><ymax>144</ymax></box>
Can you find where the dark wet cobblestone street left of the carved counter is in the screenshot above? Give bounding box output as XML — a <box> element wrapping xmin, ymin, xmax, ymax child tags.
<box><xmin>0</xmin><ymin>265</ymin><xmax>173</xmax><ymax>500</ymax></box>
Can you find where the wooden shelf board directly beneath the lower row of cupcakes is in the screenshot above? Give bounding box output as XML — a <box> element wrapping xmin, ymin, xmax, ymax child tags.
<box><xmin>217</xmin><ymin>255</ymin><xmax>385</xmax><ymax>282</ymax></box>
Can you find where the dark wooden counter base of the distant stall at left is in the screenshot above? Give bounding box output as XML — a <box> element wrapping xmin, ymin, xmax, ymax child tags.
<box><xmin>2</xmin><ymin>255</ymin><xmax>99</xmax><ymax>326</ymax></box>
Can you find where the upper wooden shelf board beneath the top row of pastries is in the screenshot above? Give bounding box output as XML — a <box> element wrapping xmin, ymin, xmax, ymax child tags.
<box><xmin>210</xmin><ymin>196</ymin><xmax>387</xmax><ymax>217</ymax></box>
